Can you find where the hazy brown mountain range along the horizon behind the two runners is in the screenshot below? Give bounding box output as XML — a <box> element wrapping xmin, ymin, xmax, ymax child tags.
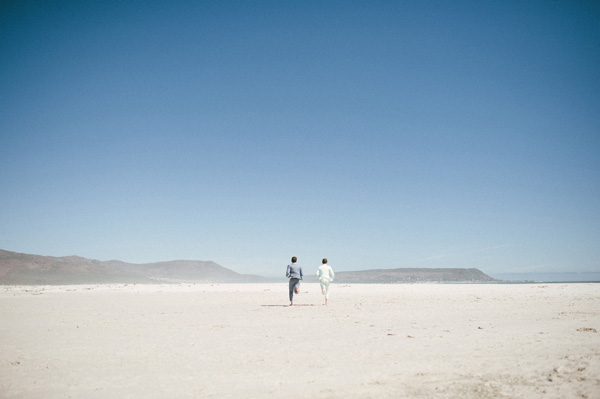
<box><xmin>0</xmin><ymin>250</ymin><xmax>497</xmax><ymax>285</ymax></box>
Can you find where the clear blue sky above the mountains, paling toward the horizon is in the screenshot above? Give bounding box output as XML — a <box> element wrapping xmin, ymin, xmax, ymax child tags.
<box><xmin>0</xmin><ymin>0</ymin><xmax>600</xmax><ymax>276</ymax></box>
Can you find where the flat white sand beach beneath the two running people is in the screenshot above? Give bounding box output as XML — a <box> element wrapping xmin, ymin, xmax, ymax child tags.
<box><xmin>0</xmin><ymin>282</ymin><xmax>600</xmax><ymax>398</ymax></box>
